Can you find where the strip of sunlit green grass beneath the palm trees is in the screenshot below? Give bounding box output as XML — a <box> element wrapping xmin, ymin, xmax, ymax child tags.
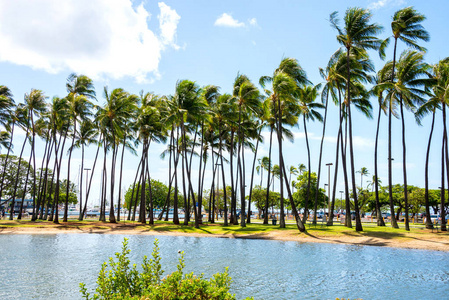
<box><xmin>0</xmin><ymin>219</ymin><xmax>449</xmax><ymax>239</ymax></box>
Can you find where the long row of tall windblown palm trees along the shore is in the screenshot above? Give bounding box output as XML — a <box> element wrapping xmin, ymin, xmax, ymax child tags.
<box><xmin>0</xmin><ymin>7</ymin><xmax>449</xmax><ymax>231</ymax></box>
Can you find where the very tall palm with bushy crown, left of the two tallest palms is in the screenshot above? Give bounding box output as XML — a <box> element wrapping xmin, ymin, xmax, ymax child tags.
<box><xmin>330</xmin><ymin>8</ymin><xmax>382</xmax><ymax>231</ymax></box>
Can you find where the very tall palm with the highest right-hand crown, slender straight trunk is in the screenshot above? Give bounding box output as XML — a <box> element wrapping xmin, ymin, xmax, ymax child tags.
<box><xmin>387</xmin><ymin>7</ymin><xmax>430</xmax><ymax>228</ymax></box>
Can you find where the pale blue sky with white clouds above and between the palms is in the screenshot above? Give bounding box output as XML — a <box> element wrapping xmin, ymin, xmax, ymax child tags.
<box><xmin>0</xmin><ymin>0</ymin><xmax>449</xmax><ymax>206</ymax></box>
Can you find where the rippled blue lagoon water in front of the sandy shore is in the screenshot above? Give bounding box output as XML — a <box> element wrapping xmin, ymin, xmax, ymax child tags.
<box><xmin>0</xmin><ymin>234</ymin><xmax>449</xmax><ymax>299</ymax></box>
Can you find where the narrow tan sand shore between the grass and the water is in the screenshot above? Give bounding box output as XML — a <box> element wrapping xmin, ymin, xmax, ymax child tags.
<box><xmin>0</xmin><ymin>222</ymin><xmax>449</xmax><ymax>251</ymax></box>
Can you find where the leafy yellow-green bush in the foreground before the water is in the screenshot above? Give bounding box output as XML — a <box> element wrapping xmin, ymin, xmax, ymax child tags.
<box><xmin>80</xmin><ymin>238</ymin><xmax>250</xmax><ymax>300</ymax></box>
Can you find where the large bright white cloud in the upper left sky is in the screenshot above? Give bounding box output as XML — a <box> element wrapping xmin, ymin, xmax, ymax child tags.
<box><xmin>0</xmin><ymin>0</ymin><xmax>180</xmax><ymax>82</ymax></box>
